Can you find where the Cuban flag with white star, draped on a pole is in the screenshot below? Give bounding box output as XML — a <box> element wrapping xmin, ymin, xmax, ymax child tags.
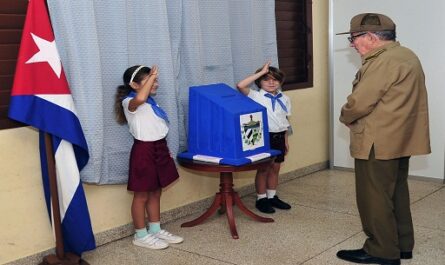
<box><xmin>9</xmin><ymin>0</ymin><xmax>96</xmax><ymax>255</ymax></box>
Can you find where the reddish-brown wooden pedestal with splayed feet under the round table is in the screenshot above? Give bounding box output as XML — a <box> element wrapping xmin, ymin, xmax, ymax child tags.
<box><xmin>181</xmin><ymin>172</ymin><xmax>274</xmax><ymax>239</ymax></box>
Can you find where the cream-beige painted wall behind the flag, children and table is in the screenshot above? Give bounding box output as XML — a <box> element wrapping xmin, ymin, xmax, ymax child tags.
<box><xmin>0</xmin><ymin>1</ymin><xmax>329</xmax><ymax>264</ymax></box>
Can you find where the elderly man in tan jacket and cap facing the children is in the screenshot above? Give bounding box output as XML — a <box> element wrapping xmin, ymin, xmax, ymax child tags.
<box><xmin>337</xmin><ymin>13</ymin><xmax>431</xmax><ymax>264</ymax></box>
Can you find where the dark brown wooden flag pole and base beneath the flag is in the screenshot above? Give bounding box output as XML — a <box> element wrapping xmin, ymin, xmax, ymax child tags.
<box><xmin>40</xmin><ymin>132</ymin><xmax>88</xmax><ymax>265</ymax></box>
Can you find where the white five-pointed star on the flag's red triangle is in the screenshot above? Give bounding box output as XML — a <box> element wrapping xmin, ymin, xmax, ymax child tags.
<box><xmin>26</xmin><ymin>33</ymin><xmax>62</xmax><ymax>78</ymax></box>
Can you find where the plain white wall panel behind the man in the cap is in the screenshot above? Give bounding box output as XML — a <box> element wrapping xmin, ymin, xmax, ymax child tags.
<box><xmin>329</xmin><ymin>0</ymin><xmax>445</xmax><ymax>179</ymax></box>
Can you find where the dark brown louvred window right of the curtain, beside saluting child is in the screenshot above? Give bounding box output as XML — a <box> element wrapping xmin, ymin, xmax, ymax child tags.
<box><xmin>275</xmin><ymin>0</ymin><xmax>313</xmax><ymax>90</ymax></box>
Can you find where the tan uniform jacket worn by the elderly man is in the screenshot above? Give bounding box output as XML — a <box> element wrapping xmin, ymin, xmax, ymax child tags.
<box><xmin>340</xmin><ymin>42</ymin><xmax>431</xmax><ymax>160</ymax></box>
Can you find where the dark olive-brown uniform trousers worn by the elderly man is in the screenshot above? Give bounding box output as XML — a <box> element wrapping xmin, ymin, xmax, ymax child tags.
<box><xmin>355</xmin><ymin>147</ymin><xmax>414</xmax><ymax>259</ymax></box>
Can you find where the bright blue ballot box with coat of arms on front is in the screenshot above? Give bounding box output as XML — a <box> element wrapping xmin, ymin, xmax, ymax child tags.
<box><xmin>178</xmin><ymin>83</ymin><xmax>280</xmax><ymax>166</ymax></box>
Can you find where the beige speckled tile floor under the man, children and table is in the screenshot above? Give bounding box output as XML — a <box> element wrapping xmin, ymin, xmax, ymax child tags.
<box><xmin>83</xmin><ymin>170</ymin><xmax>445</xmax><ymax>265</ymax></box>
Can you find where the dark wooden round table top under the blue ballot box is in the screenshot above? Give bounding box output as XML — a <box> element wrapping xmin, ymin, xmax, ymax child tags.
<box><xmin>177</xmin><ymin>156</ymin><xmax>275</xmax><ymax>172</ymax></box>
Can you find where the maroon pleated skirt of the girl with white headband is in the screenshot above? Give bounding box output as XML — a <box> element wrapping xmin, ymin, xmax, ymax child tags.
<box><xmin>127</xmin><ymin>139</ymin><xmax>179</xmax><ymax>192</ymax></box>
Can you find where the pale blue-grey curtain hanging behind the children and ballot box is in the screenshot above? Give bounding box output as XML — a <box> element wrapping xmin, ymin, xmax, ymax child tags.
<box><xmin>48</xmin><ymin>0</ymin><xmax>278</xmax><ymax>184</ymax></box>
